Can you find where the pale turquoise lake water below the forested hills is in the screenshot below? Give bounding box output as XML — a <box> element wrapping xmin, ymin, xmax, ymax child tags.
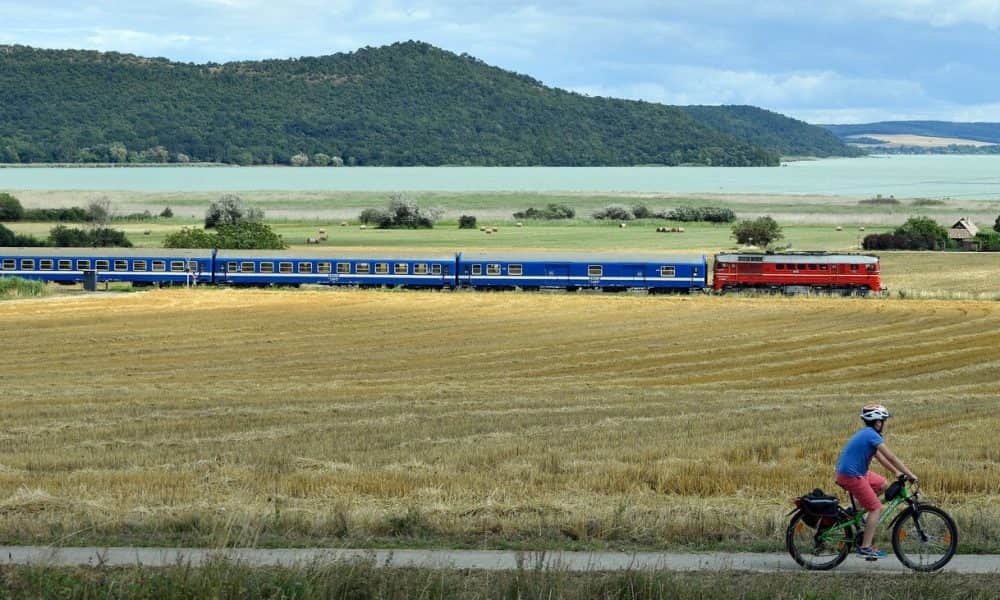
<box><xmin>0</xmin><ymin>155</ymin><xmax>1000</xmax><ymax>199</ymax></box>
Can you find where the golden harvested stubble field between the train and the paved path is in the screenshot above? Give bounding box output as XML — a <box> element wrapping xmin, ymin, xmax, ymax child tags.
<box><xmin>0</xmin><ymin>290</ymin><xmax>1000</xmax><ymax>551</ymax></box>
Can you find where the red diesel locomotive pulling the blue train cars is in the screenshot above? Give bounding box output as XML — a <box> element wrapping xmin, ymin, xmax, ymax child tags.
<box><xmin>712</xmin><ymin>252</ymin><xmax>883</xmax><ymax>296</ymax></box>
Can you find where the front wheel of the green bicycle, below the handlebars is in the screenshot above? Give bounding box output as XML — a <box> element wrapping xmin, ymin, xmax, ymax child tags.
<box><xmin>892</xmin><ymin>504</ymin><xmax>958</xmax><ymax>571</ymax></box>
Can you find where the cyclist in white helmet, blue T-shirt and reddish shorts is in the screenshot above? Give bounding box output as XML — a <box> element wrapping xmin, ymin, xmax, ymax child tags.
<box><xmin>837</xmin><ymin>404</ymin><xmax>917</xmax><ymax>558</ymax></box>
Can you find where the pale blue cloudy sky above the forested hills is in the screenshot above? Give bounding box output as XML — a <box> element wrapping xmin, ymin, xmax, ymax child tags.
<box><xmin>0</xmin><ymin>0</ymin><xmax>1000</xmax><ymax>123</ymax></box>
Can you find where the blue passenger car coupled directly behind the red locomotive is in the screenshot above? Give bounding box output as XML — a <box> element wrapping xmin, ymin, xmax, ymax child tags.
<box><xmin>458</xmin><ymin>252</ymin><xmax>708</xmax><ymax>293</ymax></box>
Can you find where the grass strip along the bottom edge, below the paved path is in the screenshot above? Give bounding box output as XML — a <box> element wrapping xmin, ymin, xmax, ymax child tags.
<box><xmin>0</xmin><ymin>561</ymin><xmax>1000</xmax><ymax>600</ymax></box>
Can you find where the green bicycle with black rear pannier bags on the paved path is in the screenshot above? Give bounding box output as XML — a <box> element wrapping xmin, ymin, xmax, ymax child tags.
<box><xmin>785</xmin><ymin>475</ymin><xmax>958</xmax><ymax>571</ymax></box>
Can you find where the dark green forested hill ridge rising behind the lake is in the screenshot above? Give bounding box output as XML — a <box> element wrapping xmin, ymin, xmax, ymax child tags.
<box><xmin>0</xmin><ymin>42</ymin><xmax>851</xmax><ymax>166</ymax></box>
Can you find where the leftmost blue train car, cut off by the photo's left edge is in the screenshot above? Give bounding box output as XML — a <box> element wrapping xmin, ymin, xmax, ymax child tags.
<box><xmin>0</xmin><ymin>248</ymin><xmax>211</xmax><ymax>285</ymax></box>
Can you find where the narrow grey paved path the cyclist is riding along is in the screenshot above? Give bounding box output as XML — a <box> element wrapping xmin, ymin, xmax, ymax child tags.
<box><xmin>0</xmin><ymin>546</ymin><xmax>1000</xmax><ymax>573</ymax></box>
